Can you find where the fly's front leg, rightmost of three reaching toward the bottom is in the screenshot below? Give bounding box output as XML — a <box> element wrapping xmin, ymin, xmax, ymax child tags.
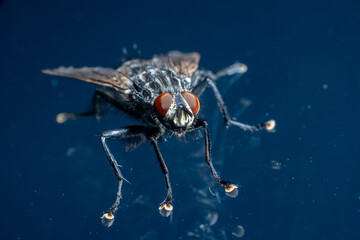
<box><xmin>195</xmin><ymin>119</ymin><xmax>239</xmax><ymax>198</ymax></box>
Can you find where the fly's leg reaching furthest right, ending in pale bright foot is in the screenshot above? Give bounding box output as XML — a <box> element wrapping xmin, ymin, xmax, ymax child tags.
<box><xmin>207</xmin><ymin>78</ymin><xmax>275</xmax><ymax>131</ymax></box>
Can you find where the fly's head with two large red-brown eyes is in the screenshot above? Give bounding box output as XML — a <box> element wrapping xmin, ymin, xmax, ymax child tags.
<box><xmin>154</xmin><ymin>91</ymin><xmax>200</xmax><ymax>134</ymax></box>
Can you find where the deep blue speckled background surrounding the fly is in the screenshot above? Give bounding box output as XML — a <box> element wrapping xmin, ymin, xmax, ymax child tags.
<box><xmin>0</xmin><ymin>0</ymin><xmax>360</xmax><ymax>240</ymax></box>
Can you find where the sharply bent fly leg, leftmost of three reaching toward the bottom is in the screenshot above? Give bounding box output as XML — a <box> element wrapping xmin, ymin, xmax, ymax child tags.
<box><xmin>101</xmin><ymin>126</ymin><xmax>147</xmax><ymax>227</ymax></box>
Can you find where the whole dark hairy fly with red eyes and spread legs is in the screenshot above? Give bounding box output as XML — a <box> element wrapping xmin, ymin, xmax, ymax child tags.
<box><xmin>43</xmin><ymin>51</ymin><xmax>275</xmax><ymax>227</ymax></box>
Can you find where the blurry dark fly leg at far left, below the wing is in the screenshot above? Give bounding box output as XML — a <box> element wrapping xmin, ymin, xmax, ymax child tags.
<box><xmin>56</xmin><ymin>89</ymin><xmax>118</xmax><ymax>123</ymax></box>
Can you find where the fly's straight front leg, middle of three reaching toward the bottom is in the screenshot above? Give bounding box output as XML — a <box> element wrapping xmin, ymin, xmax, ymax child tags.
<box><xmin>150</xmin><ymin>137</ymin><xmax>173</xmax><ymax>217</ymax></box>
